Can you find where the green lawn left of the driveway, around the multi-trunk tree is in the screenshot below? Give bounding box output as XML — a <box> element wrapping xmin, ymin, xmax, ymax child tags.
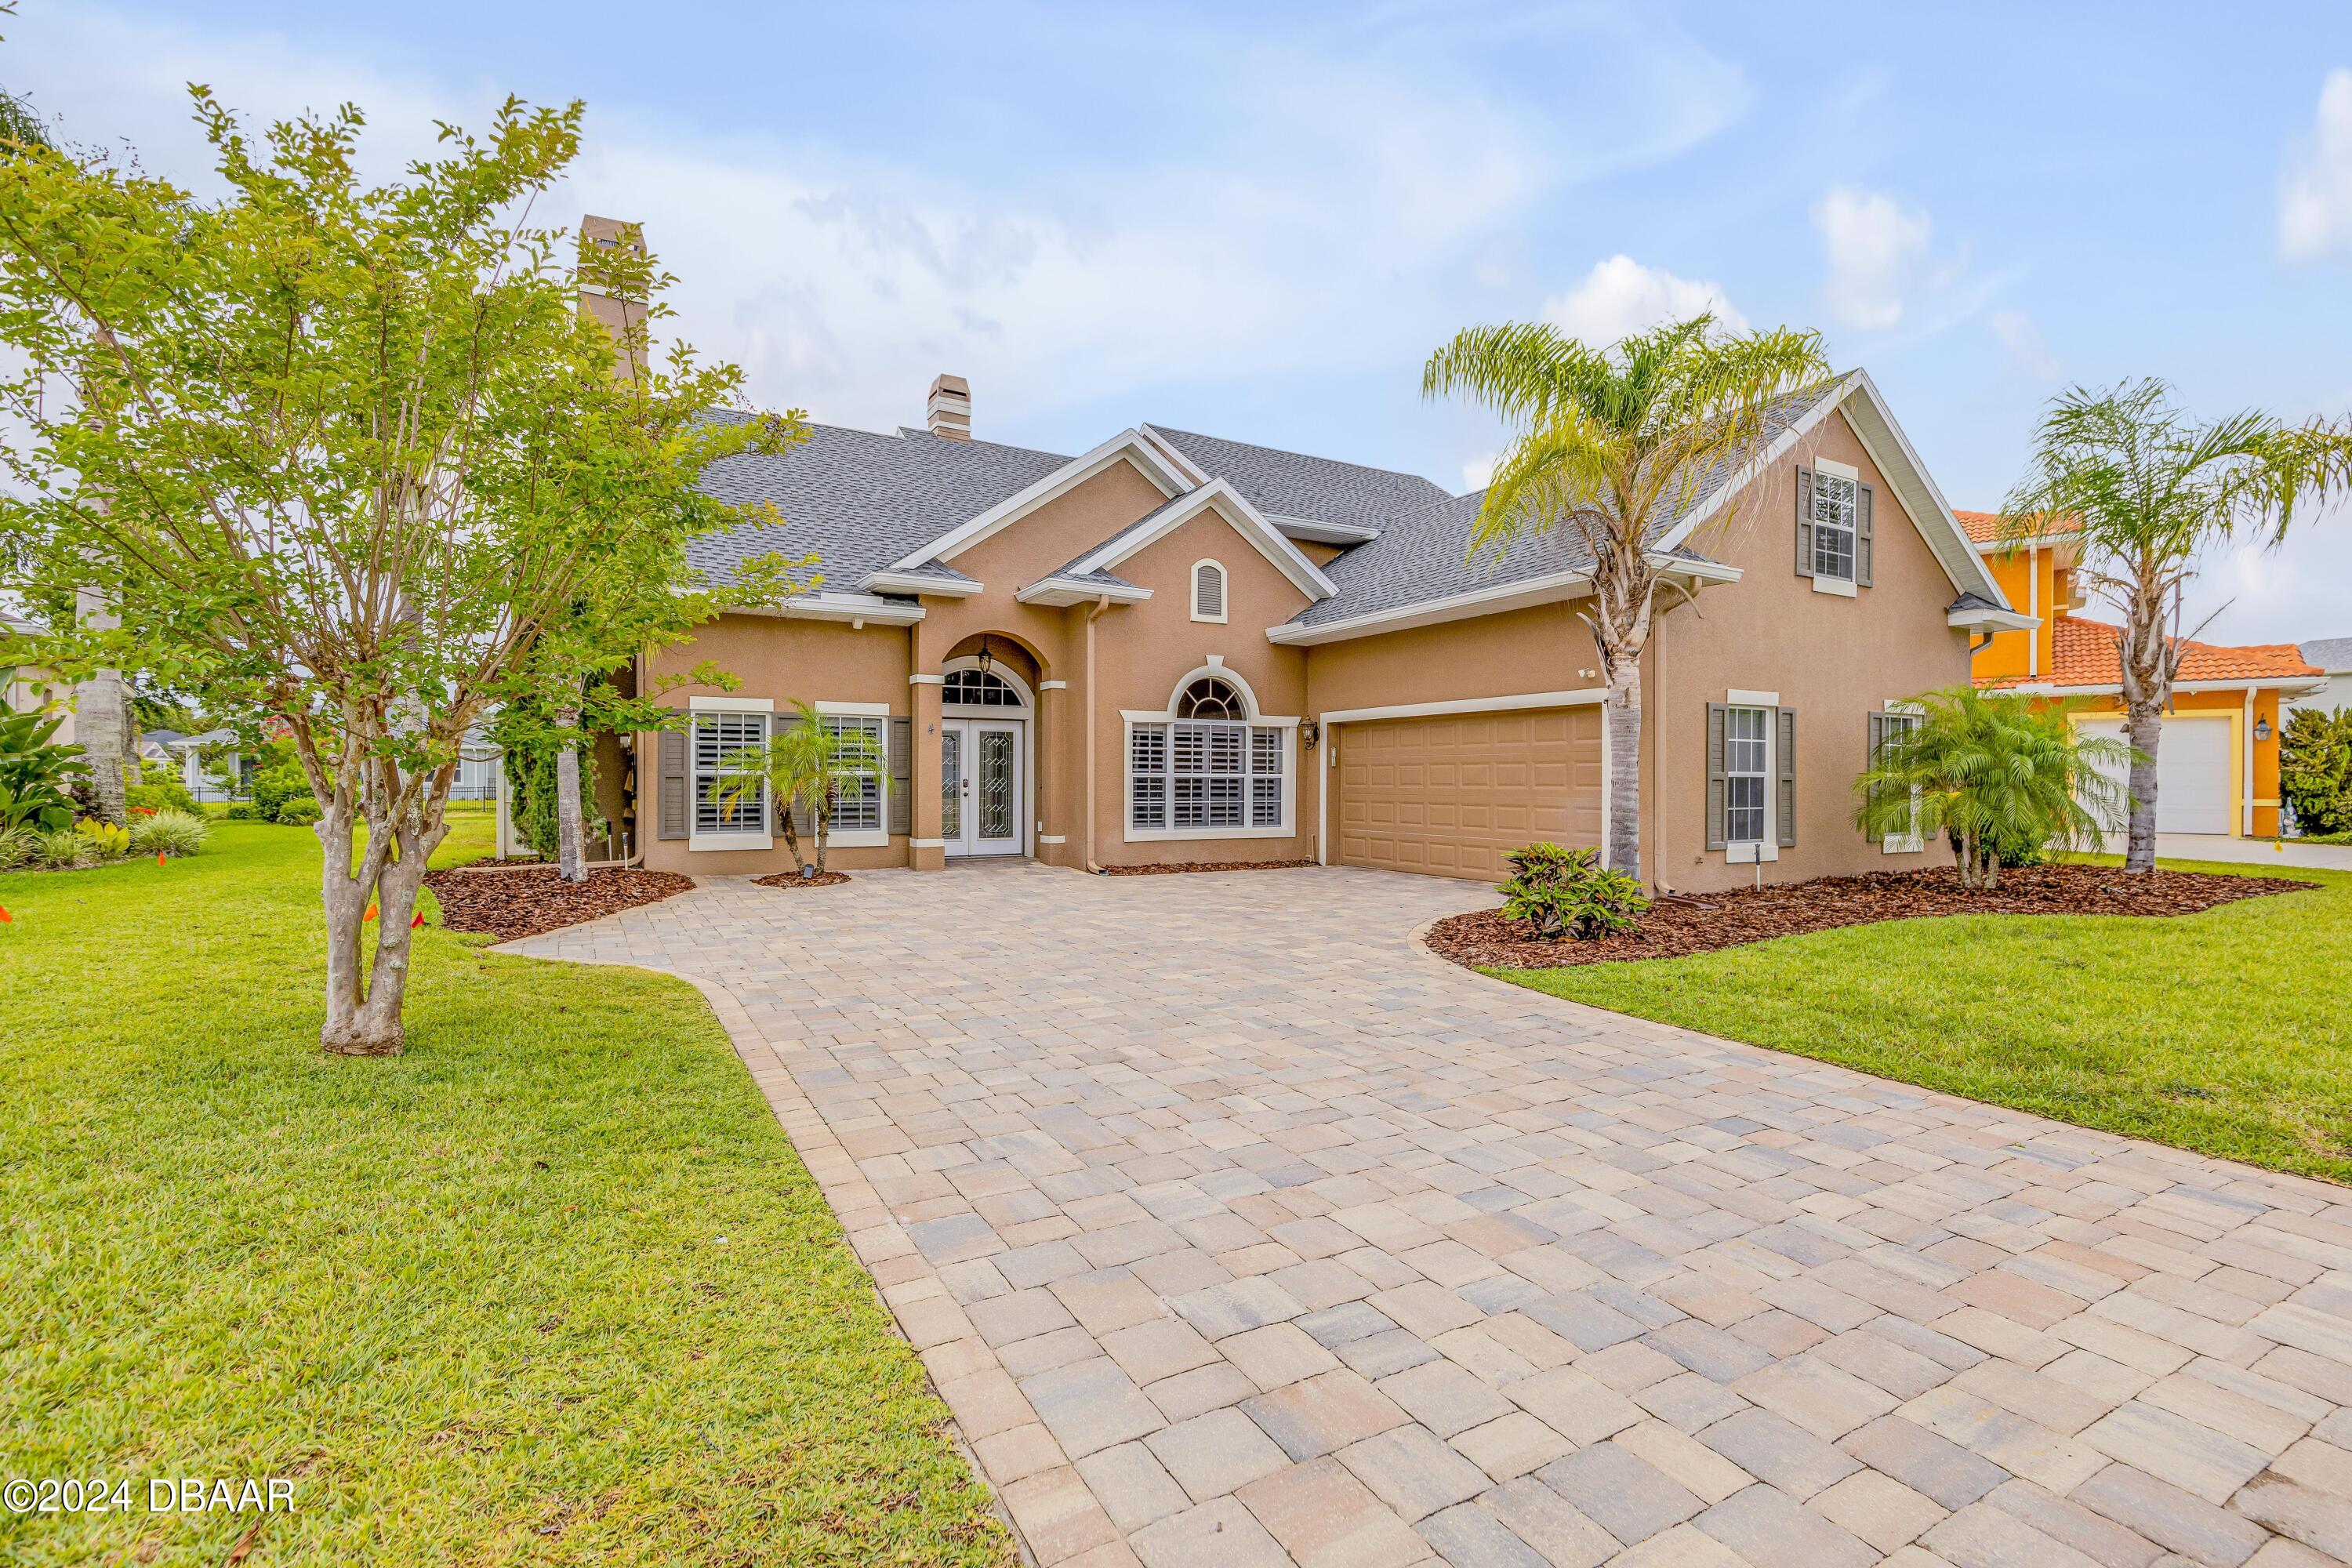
<box><xmin>0</xmin><ymin>822</ymin><xmax>1011</xmax><ymax>1568</ymax></box>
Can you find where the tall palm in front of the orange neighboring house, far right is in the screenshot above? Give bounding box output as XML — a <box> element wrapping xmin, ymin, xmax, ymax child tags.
<box><xmin>2002</xmin><ymin>379</ymin><xmax>2352</xmax><ymax>872</ymax></box>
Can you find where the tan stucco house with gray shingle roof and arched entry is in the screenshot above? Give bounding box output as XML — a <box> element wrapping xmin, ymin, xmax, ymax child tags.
<box><xmin>607</xmin><ymin>374</ymin><xmax>2030</xmax><ymax>891</ymax></box>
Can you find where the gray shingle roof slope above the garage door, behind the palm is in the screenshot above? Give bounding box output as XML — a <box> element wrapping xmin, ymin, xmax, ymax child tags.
<box><xmin>1279</xmin><ymin>383</ymin><xmax>1837</xmax><ymax>626</ymax></box>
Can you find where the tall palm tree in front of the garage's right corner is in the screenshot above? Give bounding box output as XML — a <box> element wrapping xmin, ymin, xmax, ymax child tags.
<box><xmin>1421</xmin><ymin>315</ymin><xmax>1830</xmax><ymax>877</ymax></box>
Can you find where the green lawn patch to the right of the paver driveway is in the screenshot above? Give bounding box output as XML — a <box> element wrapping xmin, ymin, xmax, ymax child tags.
<box><xmin>1489</xmin><ymin>865</ymin><xmax>2352</xmax><ymax>1180</ymax></box>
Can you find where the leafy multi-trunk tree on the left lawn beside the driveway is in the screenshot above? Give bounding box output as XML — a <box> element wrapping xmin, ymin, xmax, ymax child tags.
<box><xmin>0</xmin><ymin>87</ymin><xmax>804</xmax><ymax>1055</ymax></box>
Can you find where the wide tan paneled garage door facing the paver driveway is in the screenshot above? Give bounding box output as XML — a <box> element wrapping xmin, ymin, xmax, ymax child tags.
<box><xmin>1334</xmin><ymin>708</ymin><xmax>1602</xmax><ymax>881</ymax></box>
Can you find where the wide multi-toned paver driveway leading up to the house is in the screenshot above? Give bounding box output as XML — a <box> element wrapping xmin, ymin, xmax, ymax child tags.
<box><xmin>517</xmin><ymin>865</ymin><xmax>2352</xmax><ymax>1568</ymax></box>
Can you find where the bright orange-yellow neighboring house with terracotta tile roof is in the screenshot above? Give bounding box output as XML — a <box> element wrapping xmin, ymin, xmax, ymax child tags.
<box><xmin>1955</xmin><ymin>513</ymin><xmax>2326</xmax><ymax>837</ymax></box>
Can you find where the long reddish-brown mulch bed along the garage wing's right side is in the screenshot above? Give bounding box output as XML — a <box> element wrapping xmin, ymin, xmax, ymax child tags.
<box><xmin>1428</xmin><ymin>865</ymin><xmax>2319</xmax><ymax>968</ymax></box>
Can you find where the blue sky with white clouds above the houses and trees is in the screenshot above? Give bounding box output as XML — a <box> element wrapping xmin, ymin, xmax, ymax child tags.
<box><xmin>18</xmin><ymin>0</ymin><xmax>2352</xmax><ymax>642</ymax></box>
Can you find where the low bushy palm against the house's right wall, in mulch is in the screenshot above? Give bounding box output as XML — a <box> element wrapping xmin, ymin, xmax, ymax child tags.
<box><xmin>1853</xmin><ymin>687</ymin><xmax>2131</xmax><ymax>891</ymax></box>
